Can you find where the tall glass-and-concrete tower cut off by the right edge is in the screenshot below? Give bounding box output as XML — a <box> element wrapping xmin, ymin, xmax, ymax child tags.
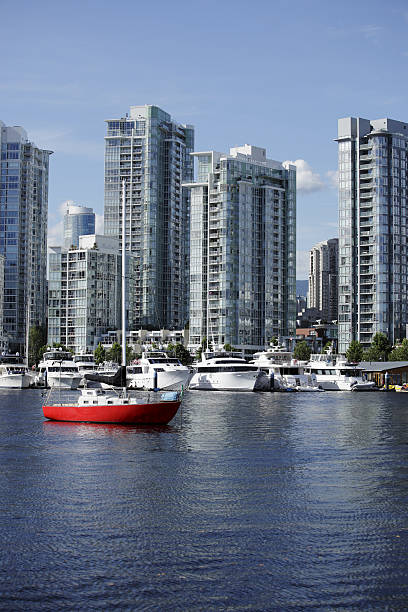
<box><xmin>337</xmin><ymin>117</ymin><xmax>408</xmax><ymax>352</ymax></box>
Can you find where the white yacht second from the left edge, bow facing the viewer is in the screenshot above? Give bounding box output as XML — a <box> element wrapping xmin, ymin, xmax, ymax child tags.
<box><xmin>35</xmin><ymin>348</ymin><xmax>82</xmax><ymax>389</ymax></box>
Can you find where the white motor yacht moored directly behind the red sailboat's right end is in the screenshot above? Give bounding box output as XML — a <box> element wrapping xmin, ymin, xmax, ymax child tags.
<box><xmin>126</xmin><ymin>351</ymin><xmax>191</xmax><ymax>390</ymax></box>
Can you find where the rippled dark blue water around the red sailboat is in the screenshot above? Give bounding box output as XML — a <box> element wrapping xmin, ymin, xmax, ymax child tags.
<box><xmin>0</xmin><ymin>390</ymin><xmax>408</xmax><ymax>611</ymax></box>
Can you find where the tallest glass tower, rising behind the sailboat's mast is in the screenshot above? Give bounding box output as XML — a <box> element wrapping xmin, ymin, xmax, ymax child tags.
<box><xmin>104</xmin><ymin>105</ymin><xmax>194</xmax><ymax>329</ymax></box>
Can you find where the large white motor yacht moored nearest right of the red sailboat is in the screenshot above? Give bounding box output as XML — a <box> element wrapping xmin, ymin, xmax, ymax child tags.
<box><xmin>189</xmin><ymin>353</ymin><xmax>263</xmax><ymax>391</ymax></box>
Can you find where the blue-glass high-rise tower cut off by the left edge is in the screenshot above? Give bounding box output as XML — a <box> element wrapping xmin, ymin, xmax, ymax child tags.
<box><xmin>0</xmin><ymin>121</ymin><xmax>52</xmax><ymax>354</ymax></box>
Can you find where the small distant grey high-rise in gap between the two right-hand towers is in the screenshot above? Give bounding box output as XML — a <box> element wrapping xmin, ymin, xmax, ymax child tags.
<box><xmin>308</xmin><ymin>238</ymin><xmax>339</xmax><ymax>322</ymax></box>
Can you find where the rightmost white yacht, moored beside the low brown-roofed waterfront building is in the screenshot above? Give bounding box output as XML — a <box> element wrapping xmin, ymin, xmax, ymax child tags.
<box><xmin>305</xmin><ymin>355</ymin><xmax>376</xmax><ymax>391</ymax></box>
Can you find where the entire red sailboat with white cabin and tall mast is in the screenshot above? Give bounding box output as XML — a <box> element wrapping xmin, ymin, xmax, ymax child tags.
<box><xmin>43</xmin><ymin>182</ymin><xmax>182</xmax><ymax>425</ymax></box>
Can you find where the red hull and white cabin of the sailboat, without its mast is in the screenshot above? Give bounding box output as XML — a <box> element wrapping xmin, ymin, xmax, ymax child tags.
<box><xmin>43</xmin><ymin>388</ymin><xmax>181</xmax><ymax>425</ymax></box>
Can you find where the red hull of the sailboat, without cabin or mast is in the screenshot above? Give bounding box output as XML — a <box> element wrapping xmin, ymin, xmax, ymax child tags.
<box><xmin>43</xmin><ymin>400</ymin><xmax>181</xmax><ymax>425</ymax></box>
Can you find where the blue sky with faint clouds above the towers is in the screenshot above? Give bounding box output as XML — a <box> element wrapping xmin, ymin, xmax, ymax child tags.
<box><xmin>0</xmin><ymin>0</ymin><xmax>408</xmax><ymax>278</ymax></box>
